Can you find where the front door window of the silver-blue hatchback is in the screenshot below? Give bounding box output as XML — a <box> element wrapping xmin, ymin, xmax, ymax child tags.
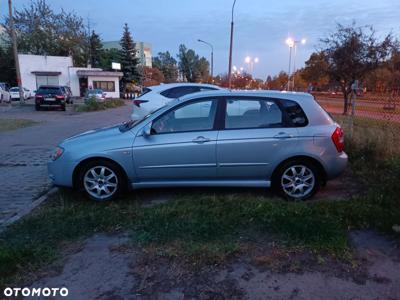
<box><xmin>151</xmin><ymin>99</ymin><xmax>218</xmax><ymax>134</ymax></box>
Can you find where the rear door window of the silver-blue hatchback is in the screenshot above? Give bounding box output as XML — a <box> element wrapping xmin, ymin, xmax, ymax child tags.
<box><xmin>225</xmin><ymin>99</ymin><xmax>284</xmax><ymax>129</ymax></box>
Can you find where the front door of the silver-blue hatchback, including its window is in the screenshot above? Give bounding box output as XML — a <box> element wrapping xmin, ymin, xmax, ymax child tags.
<box><xmin>133</xmin><ymin>98</ymin><xmax>218</xmax><ymax>182</ymax></box>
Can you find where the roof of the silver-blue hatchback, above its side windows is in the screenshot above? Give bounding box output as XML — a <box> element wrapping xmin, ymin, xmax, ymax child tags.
<box><xmin>178</xmin><ymin>90</ymin><xmax>314</xmax><ymax>101</ymax></box>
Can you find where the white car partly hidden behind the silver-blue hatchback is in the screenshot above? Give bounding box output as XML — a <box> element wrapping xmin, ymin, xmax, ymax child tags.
<box><xmin>131</xmin><ymin>83</ymin><xmax>223</xmax><ymax>120</ymax></box>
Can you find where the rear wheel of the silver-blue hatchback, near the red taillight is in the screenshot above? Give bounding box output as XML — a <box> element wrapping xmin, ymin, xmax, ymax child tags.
<box><xmin>272</xmin><ymin>160</ymin><xmax>321</xmax><ymax>201</ymax></box>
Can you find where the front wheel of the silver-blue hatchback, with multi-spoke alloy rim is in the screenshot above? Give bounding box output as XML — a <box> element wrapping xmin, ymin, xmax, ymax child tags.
<box><xmin>79</xmin><ymin>160</ymin><xmax>126</xmax><ymax>201</ymax></box>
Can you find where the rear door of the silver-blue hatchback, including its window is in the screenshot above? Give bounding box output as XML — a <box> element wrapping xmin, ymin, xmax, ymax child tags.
<box><xmin>217</xmin><ymin>97</ymin><xmax>298</xmax><ymax>180</ymax></box>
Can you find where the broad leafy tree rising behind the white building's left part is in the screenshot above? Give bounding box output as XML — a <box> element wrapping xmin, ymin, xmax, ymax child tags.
<box><xmin>3</xmin><ymin>0</ymin><xmax>87</xmax><ymax>66</ymax></box>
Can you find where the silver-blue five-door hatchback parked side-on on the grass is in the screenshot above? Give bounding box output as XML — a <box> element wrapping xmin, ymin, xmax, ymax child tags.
<box><xmin>48</xmin><ymin>90</ymin><xmax>347</xmax><ymax>201</ymax></box>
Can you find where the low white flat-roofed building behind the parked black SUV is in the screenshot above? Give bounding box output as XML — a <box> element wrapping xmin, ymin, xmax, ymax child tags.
<box><xmin>18</xmin><ymin>54</ymin><xmax>122</xmax><ymax>98</ymax></box>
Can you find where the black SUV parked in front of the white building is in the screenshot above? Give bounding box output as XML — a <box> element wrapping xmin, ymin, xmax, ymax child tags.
<box><xmin>35</xmin><ymin>85</ymin><xmax>66</xmax><ymax>111</ymax></box>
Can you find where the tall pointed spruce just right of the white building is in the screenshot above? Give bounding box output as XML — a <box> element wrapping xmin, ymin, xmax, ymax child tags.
<box><xmin>120</xmin><ymin>23</ymin><xmax>141</xmax><ymax>89</ymax></box>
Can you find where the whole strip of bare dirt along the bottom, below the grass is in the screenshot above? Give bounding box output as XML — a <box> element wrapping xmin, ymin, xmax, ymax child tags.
<box><xmin>25</xmin><ymin>231</ymin><xmax>400</xmax><ymax>299</ymax></box>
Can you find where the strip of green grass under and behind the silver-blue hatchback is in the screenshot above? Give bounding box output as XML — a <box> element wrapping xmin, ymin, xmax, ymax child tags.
<box><xmin>0</xmin><ymin>113</ymin><xmax>400</xmax><ymax>286</ymax></box>
